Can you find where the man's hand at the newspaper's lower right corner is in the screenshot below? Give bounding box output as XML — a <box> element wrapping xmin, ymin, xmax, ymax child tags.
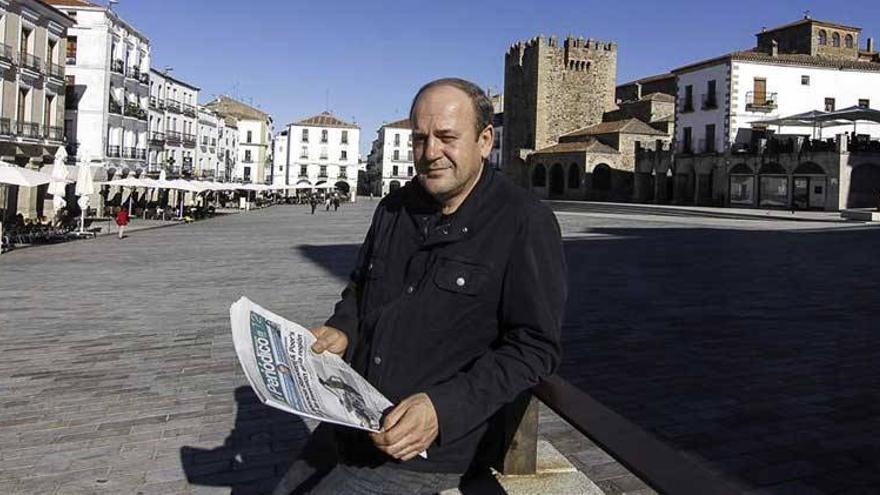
<box><xmin>370</xmin><ymin>394</ymin><xmax>439</xmax><ymax>461</ymax></box>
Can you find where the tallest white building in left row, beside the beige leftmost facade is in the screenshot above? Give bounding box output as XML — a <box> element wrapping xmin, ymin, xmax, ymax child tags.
<box><xmin>49</xmin><ymin>0</ymin><xmax>150</xmax><ymax>176</ymax></box>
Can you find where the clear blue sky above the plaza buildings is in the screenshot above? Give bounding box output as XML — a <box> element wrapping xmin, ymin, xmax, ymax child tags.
<box><xmin>111</xmin><ymin>0</ymin><xmax>880</xmax><ymax>156</ymax></box>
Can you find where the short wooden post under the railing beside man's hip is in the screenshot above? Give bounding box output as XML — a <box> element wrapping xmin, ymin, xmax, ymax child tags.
<box><xmin>501</xmin><ymin>391</ymin><xmax>539</xmax><ymax>475</ymax></box>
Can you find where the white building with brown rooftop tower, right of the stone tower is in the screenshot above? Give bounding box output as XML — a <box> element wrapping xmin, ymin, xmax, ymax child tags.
<box><xmin>673</xmin><ymin>18</ymin><xmax>880</xmax><ymax>154</ymax></box>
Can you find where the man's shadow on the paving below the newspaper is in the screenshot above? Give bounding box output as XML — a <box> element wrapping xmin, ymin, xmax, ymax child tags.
<box><xmin>180</xmin><ymin>386</ymin><xmax>309</xmax><ymax>495</ymax></box>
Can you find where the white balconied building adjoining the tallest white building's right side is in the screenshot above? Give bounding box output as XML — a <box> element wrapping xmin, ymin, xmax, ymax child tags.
<box><xmin>149</xmin><ymin>69</ymin><xmax>199</xmax><ymax>177</ymax></box>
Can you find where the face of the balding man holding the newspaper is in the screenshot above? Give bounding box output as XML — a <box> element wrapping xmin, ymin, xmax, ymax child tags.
<box><xmin>412</xmin><ymin>86</ymin><xmax>493</xmax><ymax>211</ymax></box>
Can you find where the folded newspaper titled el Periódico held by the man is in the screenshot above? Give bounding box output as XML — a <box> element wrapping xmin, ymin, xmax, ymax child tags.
<box><xmin>229</xmin><ymin>297</ymin><xmax>392</xmax><ymax>431</ymax></box>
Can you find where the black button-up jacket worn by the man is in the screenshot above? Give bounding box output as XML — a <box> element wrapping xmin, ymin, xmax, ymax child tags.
<box><xmin>327</xmin><ymin>166</ymin><xmax>566</xmax><ymax>473</ymax></box>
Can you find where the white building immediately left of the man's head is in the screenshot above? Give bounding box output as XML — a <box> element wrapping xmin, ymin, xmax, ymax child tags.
<box><xmin>371</xmin><ymin>119</ymin><xmax>415</xmax><ymax>196</ymax></box>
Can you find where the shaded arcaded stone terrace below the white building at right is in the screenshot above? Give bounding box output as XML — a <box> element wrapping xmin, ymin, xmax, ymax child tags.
<box><xmin>636</xmin><ymin>134</ymin><xmax>880</xmax><ymax>211</ymax></box>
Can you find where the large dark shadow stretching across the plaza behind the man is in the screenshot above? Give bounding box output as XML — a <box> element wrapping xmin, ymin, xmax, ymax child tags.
<box><xmin>302</xmin><ymin>224</ymin><xmax>880</xmax><ymax>493</ymax></box>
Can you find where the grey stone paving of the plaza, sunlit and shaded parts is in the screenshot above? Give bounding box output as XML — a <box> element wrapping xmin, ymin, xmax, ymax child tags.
<box><xmin>0</xmin><ymin>200</ymin><xmax>880</xmax><ymax>494</ymax></box>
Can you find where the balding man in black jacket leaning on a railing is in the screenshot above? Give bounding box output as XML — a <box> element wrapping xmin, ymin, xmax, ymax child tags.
<box><xmin>284</xmin><ymin>79</ymin><xmax>565</xmax><ymax>494</ymax></box>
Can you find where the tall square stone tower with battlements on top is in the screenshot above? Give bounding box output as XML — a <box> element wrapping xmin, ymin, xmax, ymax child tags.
<box><xmin>502</xmin><ymin>36</ymin><xmax>617</xmax><ymax>184</ymax></box>
